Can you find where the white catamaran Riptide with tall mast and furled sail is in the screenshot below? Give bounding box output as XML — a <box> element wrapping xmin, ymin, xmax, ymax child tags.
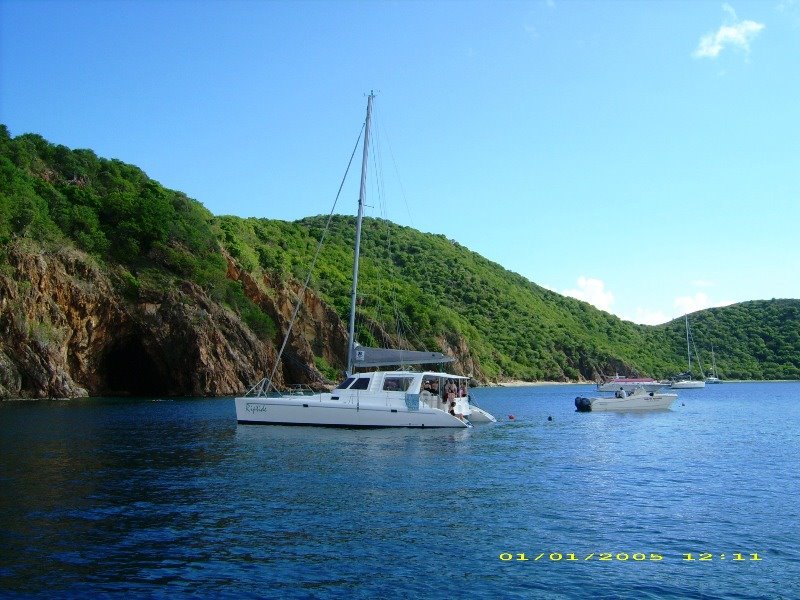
<box><xmin>235</xmin><ymin>94</ymin><xmax>496</xmax><ymax>428</ymax></box>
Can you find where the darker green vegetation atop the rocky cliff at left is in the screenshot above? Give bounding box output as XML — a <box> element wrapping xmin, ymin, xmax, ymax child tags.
<box><xmin>0</xmin><ymin>125</ymin><xmax>275</xmax><ymax>337</ymax></box>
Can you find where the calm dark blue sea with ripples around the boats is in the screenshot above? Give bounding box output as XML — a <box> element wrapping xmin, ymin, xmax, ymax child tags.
<box><xmin>0</xmin><ymin>383</ymin><xmax>800</xmax><ymax>599</ymax></box>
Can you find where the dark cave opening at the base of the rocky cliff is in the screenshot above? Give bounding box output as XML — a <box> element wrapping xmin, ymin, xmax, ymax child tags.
<box><xmin>103</xmin><ymin>336</ymin><xmax>175</xmax><ymax>396</ymax></box>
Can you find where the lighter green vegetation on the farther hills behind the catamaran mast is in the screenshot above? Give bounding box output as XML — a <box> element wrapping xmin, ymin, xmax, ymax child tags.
<box><xmin>220</xmin><ymin>216</ymin><xmax>800</xmax><ymax>380</ymax></box>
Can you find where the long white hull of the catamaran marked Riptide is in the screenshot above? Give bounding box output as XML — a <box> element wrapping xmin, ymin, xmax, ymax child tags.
<box><xmin>235</xmin><ymin>396</ymin><xmax>468</xmax><ymax>429</ymax></box>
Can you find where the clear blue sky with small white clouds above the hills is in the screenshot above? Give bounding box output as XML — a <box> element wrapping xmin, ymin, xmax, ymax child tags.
<box><xmin>0</xmin><ymin>0</ymin><xmax>800</xmax><ymax>323</ymax></box>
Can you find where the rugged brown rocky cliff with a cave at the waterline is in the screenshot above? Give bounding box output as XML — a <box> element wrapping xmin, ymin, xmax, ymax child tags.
<box><xmin>0</xmin><ymin>240</ymin><xmax>346</xmax><ymax>398</ymax></box>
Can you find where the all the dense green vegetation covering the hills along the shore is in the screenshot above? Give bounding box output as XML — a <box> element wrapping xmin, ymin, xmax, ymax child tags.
<box><xmin>0</xmin><ymin>126</ymin><xmax>800</xmax><ymax>380</ymax></box>
